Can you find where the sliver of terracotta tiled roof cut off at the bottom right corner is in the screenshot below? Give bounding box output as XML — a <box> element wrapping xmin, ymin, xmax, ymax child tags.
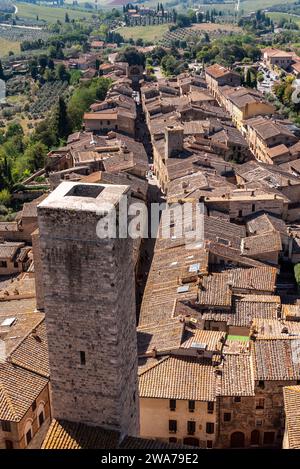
<box><xmin>283</xmin><ymin>386</ymin><xmax>300</xmax><ymax>449</ymax></box>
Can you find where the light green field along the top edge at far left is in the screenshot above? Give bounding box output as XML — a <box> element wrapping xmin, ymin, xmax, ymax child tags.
<box><xmin>17</xmin><ymin>3</ymin><xmax>92</xmax><ymax>23</ymax></box>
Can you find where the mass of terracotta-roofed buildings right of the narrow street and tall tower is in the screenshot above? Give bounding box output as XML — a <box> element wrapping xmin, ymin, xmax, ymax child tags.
<box><xmin>138</xmin><ymin>64</ymin><xmax>300</xmax><ymax>448</ymax></box>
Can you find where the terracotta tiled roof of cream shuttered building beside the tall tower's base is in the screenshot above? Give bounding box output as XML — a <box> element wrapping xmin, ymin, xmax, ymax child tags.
<box><xmin>139</xmin><ymin>356</ymin><xmax>216</xmax><ymax>401</ymax></box>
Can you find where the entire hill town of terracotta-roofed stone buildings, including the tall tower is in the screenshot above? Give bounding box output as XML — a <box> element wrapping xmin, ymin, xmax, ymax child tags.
<box><xmin>0</xmin><ymin>54</ymin><xmax>300</xmax><ymax>449</ymax></box>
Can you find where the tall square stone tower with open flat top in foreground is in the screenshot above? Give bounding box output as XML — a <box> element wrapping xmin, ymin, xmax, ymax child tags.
<box><xmin>38</xmin><ymin>182</ymin><xmax>139</xmax><ymax>435</ymax></box>
